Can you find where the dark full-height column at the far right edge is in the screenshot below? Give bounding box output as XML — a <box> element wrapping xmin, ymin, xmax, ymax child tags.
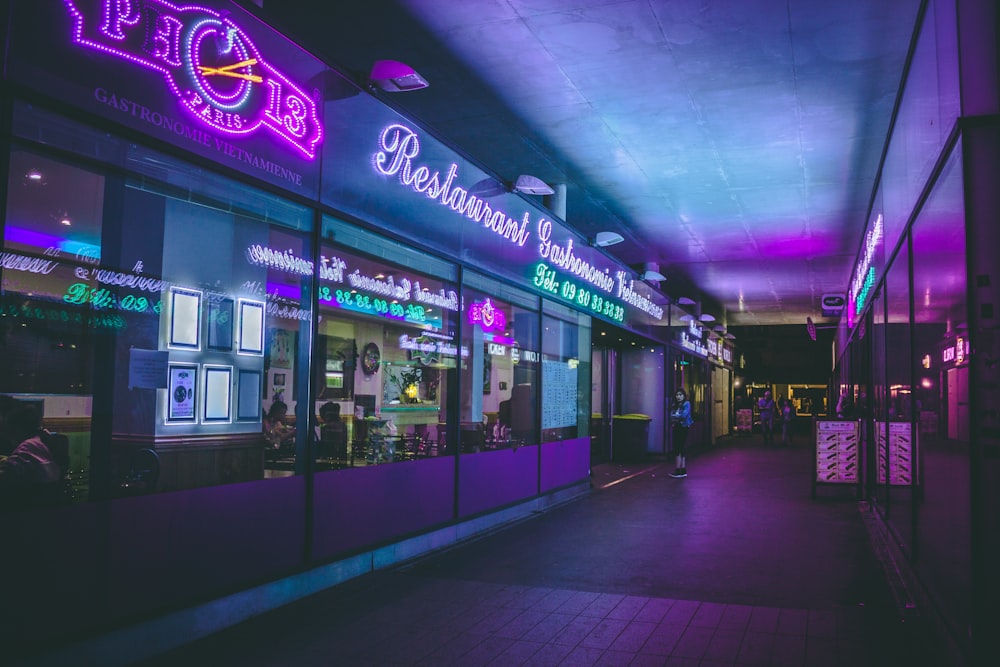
<box><xmin>956</xmin><ymin>0</ymin><xmax>1000</xmax><ymax>665</ymax></box>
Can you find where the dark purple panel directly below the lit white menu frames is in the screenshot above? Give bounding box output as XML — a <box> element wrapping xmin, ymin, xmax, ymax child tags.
<box><xmin>109</xmin><ymin>476</ymin><xmax>305</xmax><ymax>618</ymax></box>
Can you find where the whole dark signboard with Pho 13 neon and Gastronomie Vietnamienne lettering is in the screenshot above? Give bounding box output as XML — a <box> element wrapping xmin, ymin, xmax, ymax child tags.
<box><xmin>8</xmin><ymin>0</ymin><xmax>328</xmax><ymax>196</ymax></box>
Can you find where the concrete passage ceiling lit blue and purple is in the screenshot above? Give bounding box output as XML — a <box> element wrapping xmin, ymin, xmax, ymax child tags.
<box><xmin>264</xmin><ymin>0</ymin><xmax>919</xmax><ymax>326</ymax></box>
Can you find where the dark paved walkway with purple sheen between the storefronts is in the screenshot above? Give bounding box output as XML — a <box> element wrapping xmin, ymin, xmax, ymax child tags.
<box><xmin>137</xmin><ymin>437</ymin><xmax>945</xmax><ymax>667</ymax></box>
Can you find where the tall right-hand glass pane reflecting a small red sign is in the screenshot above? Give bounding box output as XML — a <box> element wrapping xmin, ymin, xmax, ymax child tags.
<box><xmin>912</xmin><ymin>142</ymin><xmax>975</xmax><ymax>636</ymax></box>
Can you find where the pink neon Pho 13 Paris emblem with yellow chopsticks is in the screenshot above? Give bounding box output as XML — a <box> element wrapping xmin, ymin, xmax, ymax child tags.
<box><xmin>63</xmin><ymin>0</ymin><xmax>323</xmax><ymax>160</ymax></box>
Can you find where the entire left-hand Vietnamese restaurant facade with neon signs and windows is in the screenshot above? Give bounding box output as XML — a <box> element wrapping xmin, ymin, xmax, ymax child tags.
<box><xmin>0</xmin><ymin>0</ymin><xmax>733</xmax><ymax>651</ymax></box>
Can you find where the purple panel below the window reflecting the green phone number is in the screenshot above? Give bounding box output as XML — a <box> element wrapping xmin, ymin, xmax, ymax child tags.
<box><xmin>313</xmin><ymin>456</ymin><xmax>455</xmax><ymax>561</ymax></box>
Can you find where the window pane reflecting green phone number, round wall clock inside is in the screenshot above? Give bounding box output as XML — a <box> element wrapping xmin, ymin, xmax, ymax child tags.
<box><xmin>311</xmin><ymin>218</ymin><xmax>467</xmax><ymax>470</ymax></box>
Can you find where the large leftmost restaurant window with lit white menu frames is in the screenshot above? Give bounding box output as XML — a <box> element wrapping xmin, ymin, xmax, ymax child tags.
<box><xmin>0</xmin><ymin>129</ymin><xmax>312</xmax><ymax>501</ymax></box>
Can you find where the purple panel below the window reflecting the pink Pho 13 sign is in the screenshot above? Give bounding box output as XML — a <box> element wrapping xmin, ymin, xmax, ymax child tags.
<box><xmin>458</xmin><ymin>445</ymin><xmax>538</xmax><ymax>517</ymax></box>
